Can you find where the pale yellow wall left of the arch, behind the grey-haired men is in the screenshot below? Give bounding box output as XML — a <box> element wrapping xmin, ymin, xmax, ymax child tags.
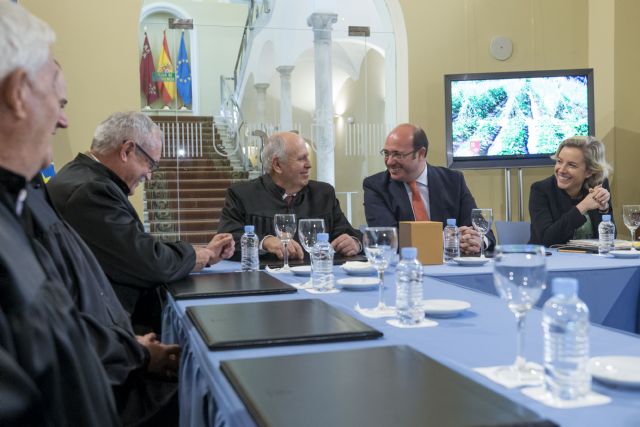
<box><xmin>20</xmin><ymin>0</ymin><xmax>142</xmax><ymax>211</ymax></box>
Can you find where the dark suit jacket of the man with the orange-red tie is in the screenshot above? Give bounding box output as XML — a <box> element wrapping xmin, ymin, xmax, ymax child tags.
<box><xmin>362</xmin><ymin>164</ymin><xmax>496</xmax><ymax>249</ymax></box>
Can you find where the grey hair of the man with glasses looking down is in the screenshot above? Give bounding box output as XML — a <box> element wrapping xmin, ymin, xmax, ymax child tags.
<box><xmin>91</xmin><ymin>111</ymin><xmax>162</xmax><ymax>154</ymax></box>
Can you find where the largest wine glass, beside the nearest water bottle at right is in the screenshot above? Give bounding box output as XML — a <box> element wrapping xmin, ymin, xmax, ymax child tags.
<box><xmin>493</xmin><ymin>245</ymin><xmax>547</xmax><ymax>385</ymax></box>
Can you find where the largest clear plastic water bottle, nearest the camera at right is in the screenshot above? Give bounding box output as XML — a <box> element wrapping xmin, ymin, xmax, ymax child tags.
<box><xmin>542</xmin><ymin>278</ymin><xmax>591</xmax><ymax>400</ymax></box>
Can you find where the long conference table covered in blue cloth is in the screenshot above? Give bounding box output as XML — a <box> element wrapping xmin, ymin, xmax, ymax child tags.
<box><xmin>163</xmin><ymin>253</ymin><xmax>640</xmax><ymax>426</ymax></box>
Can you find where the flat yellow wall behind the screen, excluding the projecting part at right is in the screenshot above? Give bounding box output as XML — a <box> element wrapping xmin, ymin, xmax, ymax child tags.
<box><xmin>400</xmin><ymin>0</ymin><xmax>588</xmax><ymax>219</ymax></box>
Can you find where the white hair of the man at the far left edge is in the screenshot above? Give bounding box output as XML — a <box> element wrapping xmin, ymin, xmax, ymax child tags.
<box><xmin>0</xmin><ymin>0</ymin><xmax>56</xmax><ymax>81</ymax></box>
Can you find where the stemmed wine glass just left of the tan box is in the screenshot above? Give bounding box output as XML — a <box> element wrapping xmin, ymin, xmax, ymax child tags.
<box><xmin>362</xmin><ymin>227</ymin><xmax>398</xmax><ymax>315</ymax></box>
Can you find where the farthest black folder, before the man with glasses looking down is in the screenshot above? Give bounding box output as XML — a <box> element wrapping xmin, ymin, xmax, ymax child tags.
<box><xmin>166</xmin><ymin>271</ymin><xmax>297</xmax><ymax>299</ymax></box>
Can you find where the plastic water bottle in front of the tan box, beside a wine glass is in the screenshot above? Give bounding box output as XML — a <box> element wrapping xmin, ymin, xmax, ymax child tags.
<box><xmin>396</xmin><ymin>248</ymin><xmax>424</xmax><ymax>325</ymax></box>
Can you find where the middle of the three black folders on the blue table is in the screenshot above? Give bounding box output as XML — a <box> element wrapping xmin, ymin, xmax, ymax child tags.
<box><xmin>187</xmin><ymin>299</ymin><xmax>382</xmax><ymax>350</ymax></box>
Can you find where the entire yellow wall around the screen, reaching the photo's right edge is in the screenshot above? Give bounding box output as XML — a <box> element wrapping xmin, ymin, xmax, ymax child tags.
<box><xmin>400</xmin><ymin>0</ymin><xmax>640</xmax><ymax>229</ymax></box>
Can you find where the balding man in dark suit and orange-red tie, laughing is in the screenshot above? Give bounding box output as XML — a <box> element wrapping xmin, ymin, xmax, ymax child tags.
<box><xmin>363</xmin><ymin>123</ymin><xmax>495</xmax><ymax>254</ymax></box>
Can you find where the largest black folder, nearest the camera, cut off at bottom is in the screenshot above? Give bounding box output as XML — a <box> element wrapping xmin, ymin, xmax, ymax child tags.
<box><xmin>220</xmin><ymin>346</ymin><xmax>555</xmax><ymax>427</ymax></box>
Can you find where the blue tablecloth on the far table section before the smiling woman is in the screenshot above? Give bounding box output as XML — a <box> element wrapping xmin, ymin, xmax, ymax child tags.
<box><xmin>425</xmin><ymin>251</ymin><xmax>640</xmax><ymax>333</ymax></box>
